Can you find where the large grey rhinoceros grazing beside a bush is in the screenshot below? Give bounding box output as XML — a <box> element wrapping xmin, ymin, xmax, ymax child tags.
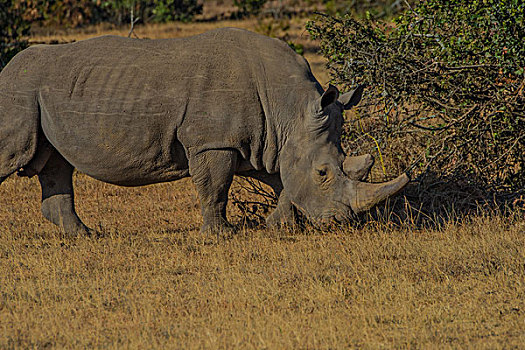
<box><xmin>0</xmin><ymin>29</ymin><xmax>408</xmax><ymax>235</ymax></box>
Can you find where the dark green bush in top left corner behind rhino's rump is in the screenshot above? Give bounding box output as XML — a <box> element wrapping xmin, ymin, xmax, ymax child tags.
<box><xmin>0</xmin><ymin>0</ymin><xmax>29</xmax><ymax>70</ymax></box>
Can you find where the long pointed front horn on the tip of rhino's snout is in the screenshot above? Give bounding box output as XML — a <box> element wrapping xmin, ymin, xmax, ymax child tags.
<box><xmin>350</xmin><ymin>174</ymin><xmax>410</xmax><ymax>214</ymax></box>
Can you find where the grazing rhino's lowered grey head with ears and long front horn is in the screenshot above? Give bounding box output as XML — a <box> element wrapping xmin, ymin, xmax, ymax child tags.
<box><xmin>281</xmin><ymin>85</ymin><xmax>409</xmax><ymax>221</ymax></box>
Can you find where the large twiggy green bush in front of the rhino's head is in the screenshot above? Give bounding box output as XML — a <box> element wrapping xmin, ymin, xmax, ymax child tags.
<box><xmin>308</xmin><ymin>0</ymin><xmax>525</xmax><ymax>205</ymax></box>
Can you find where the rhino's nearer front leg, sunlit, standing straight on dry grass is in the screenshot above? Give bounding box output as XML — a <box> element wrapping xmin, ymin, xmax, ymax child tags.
<box><xmin>190</xmin><ymin>149</ymin><xmax>237</xmax><ymax>232</ymax></box>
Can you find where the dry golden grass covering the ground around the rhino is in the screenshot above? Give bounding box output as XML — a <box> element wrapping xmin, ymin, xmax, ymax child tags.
<box><xmin>0</xmin><ymin>21</ymin><xmax>525</xmax><ymax>349</ymax></box>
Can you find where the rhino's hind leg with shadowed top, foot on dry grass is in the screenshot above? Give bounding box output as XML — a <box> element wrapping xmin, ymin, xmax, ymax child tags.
<box><xmin>38</xmin><ymin>151</ymin><xmax>90</xmax><ymax>236</ymax></box>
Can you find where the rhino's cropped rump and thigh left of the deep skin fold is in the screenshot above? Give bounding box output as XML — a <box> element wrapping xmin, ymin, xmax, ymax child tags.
<box><xmin>0</xmin><ymin>54</ymin><xmax>40</xmax><ymax>182</ymax></box>
